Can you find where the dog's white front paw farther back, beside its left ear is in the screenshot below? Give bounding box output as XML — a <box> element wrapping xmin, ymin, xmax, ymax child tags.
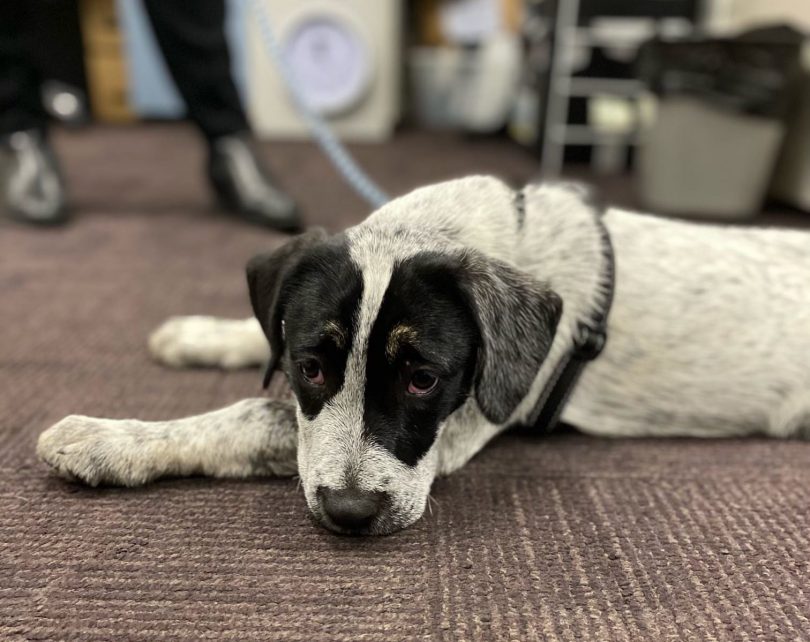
<box><xmin>149</xmin><ymin>316</ymin><xmax>269</xmax><ymax>370</ymax></box>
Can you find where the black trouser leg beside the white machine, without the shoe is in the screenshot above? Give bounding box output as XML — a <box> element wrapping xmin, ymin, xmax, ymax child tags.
<box><xmin>144</xmin><ymin>0</ymin><xmax>249</xmax><ymax>140</ymax></box>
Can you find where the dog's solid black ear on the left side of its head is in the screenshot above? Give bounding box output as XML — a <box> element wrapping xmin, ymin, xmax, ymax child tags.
<box><xmin>245</xmin><ymin>228</ymin><xmax>327</xmax><ymax>388</ymax></box>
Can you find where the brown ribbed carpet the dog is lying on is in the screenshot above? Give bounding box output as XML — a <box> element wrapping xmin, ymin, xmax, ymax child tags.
<box><xmin>0</xmin><ymin>126</ymin><xmax>810</xmax><ymax>641</ymax></box>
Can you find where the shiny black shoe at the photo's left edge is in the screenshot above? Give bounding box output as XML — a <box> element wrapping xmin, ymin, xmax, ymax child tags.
<box><xmin>0</xmin><ymin>130</ymin><xmax>68</xmax><ymax>225</ymax></box>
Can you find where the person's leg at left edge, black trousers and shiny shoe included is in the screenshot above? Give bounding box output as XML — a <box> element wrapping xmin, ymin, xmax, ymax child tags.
<box><xmin>0</xmin><ymin>0</ymin><xmax>66</xmax><ymax>224</ymax></box>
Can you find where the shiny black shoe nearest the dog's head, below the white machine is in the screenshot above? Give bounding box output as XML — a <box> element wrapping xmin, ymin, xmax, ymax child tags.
<box><xmin>208</xmin><ymin>136</ymin><xmax>301</xmax><ymax>232</ymax></box>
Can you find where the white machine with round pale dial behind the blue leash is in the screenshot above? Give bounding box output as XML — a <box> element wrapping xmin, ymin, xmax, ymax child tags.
<box><xmin>247</xmin><ymin>0</ymin><xmax>402</xmax><ymax>142</ymax></box>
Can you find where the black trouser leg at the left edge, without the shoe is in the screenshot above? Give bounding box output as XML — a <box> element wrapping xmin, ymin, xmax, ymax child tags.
<box><xmin>0</xmin><ymin>0</ymin><xmax>48</xmax><ymax>136</ymax></box>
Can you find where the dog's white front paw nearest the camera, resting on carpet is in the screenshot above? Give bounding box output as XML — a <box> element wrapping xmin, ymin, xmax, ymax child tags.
<box><xmin>37</xmin><ymin>415</ymin><xmax>154</xmax><ymax>486</ymax></box>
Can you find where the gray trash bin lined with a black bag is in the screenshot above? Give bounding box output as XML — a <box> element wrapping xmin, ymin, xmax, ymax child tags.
<box><xmin>638</xmin><ymin>28</ymin><xmax>801</xmax><ymax>219</ymax></box>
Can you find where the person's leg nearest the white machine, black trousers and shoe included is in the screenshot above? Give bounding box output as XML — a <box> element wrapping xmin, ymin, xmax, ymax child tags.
<box><xmin>144</xmin><ymin>0</ymin><xmax>299</xmax><ymax>230</ymax></box>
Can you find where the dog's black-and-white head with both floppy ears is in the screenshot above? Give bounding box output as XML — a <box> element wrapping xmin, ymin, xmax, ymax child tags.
<box><xmin>247</xmin><ymin>201</ymin><xmax>561</xmax><ymax>534</ymax></box>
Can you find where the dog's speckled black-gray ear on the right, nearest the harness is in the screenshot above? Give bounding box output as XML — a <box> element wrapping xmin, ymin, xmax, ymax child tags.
<box><xmin>454</xmin><ymin>251</ymin><xmax>562</xmax><ymax>423</ymax></box>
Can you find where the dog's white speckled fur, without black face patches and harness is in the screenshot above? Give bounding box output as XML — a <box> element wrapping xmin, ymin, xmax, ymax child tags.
<box><xmin>38</xmin><ymin>177</ymin><xmax>810</xmax><ymax>533</ymax></box>
